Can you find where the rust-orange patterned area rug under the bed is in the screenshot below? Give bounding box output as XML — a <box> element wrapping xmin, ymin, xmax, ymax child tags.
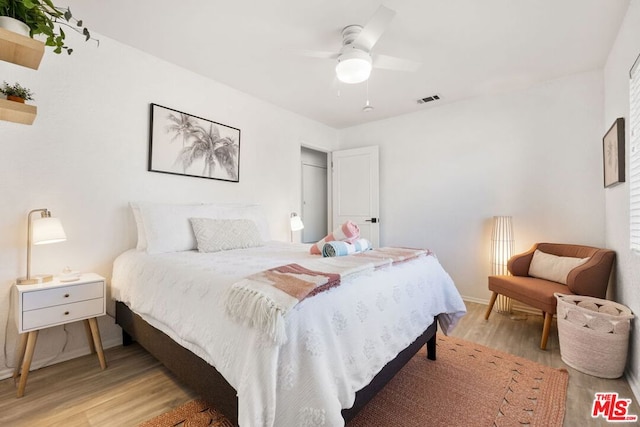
<box><xmin>140</xmin><ymin>334</ymin><xmax>569</xmax><ymax>427</ymax></box>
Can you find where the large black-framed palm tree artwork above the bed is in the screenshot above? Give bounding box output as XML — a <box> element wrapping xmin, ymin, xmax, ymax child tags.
<box><xmin>148</xmin><ymin>104</ymin><xmax>240</xmax><ymax>182</ymax></box>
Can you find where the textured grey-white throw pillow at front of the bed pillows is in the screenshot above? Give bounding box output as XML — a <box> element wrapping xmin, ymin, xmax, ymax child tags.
<box><xmin>190</xmin><ymin>218</ymin><xmax>264</xmax><ymax>252</ymax></box>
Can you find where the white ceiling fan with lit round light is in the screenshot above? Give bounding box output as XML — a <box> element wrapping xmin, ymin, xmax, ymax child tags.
<box><xmin>303</xmin><ymin>5</ymin><xmax>421</xmax><ymax>84</ymax></box>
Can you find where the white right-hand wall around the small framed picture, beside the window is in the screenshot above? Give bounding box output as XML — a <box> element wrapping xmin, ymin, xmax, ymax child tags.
<box><xmin>600</xmin><ymin>0</ymin><xmax>640</xmax><ymax>397</ymax></box>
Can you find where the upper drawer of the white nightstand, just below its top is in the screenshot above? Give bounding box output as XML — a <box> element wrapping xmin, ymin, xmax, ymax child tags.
<box><xmin>22</xmin><ymin>282</ymin><xmax>104</xmax><ymax>311</ymax></box>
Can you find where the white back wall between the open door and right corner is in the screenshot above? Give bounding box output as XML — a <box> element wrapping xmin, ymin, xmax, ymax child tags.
<box><xmin>339</xmin><ymin>71</ymin><xmax>605</xmax><ymax>302</ymax></box>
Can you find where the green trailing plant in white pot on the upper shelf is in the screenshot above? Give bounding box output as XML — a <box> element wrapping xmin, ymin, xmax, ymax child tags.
<box><xmin>0</xmin><ymin>0</ymin><xmax>99</xmax><ymax>55</ymax></box>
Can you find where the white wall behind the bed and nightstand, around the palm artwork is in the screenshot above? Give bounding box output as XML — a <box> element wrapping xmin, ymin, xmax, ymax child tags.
<box><xmin>0</xmin><ymin>35</ymin><xmax>336</xmax><ymax>378</ymax></box>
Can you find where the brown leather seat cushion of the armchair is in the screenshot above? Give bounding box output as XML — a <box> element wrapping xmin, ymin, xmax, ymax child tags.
<box><xmin>489</xmin><ymin>276</ymin><xmax>573</xmax><ymax>314</ymax></box>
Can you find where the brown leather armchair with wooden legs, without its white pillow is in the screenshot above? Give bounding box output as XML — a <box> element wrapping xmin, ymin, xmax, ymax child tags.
<box><xmin>484</xmin><ymin>243</ymin><xmax>615</xmax><ymax>350</ymax></box>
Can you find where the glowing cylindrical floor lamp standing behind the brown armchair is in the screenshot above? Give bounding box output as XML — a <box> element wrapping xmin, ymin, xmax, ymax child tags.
<box><xmin>491</xmin><ymin>216</ymin><xmax>513</xmax><ymax>313</ymax></box>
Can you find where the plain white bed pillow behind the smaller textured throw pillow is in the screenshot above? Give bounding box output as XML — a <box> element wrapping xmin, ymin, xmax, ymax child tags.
<box><xmin>131</xmin><ymin>202</ymin><xmax>269</xmax><ymax>254</ymax></box>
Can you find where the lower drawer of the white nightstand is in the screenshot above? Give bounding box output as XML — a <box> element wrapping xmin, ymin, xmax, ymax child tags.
<box><xmin>22</xmin><ymin>298</ymin><xmax>104</xmax><ymax>331</ymax></box>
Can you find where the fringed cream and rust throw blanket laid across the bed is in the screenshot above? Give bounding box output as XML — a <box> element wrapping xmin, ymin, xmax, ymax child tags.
<box><xmin>225</xmin><ymin>248</ymin><xmax>431</xmax><ymax>344</ymax></box>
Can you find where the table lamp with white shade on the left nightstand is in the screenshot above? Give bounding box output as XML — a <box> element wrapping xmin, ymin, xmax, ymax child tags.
<box><xmin>18</xmin><ymin>209</ymin><xmax>67</xmax><ymax>285</ymax></box>
